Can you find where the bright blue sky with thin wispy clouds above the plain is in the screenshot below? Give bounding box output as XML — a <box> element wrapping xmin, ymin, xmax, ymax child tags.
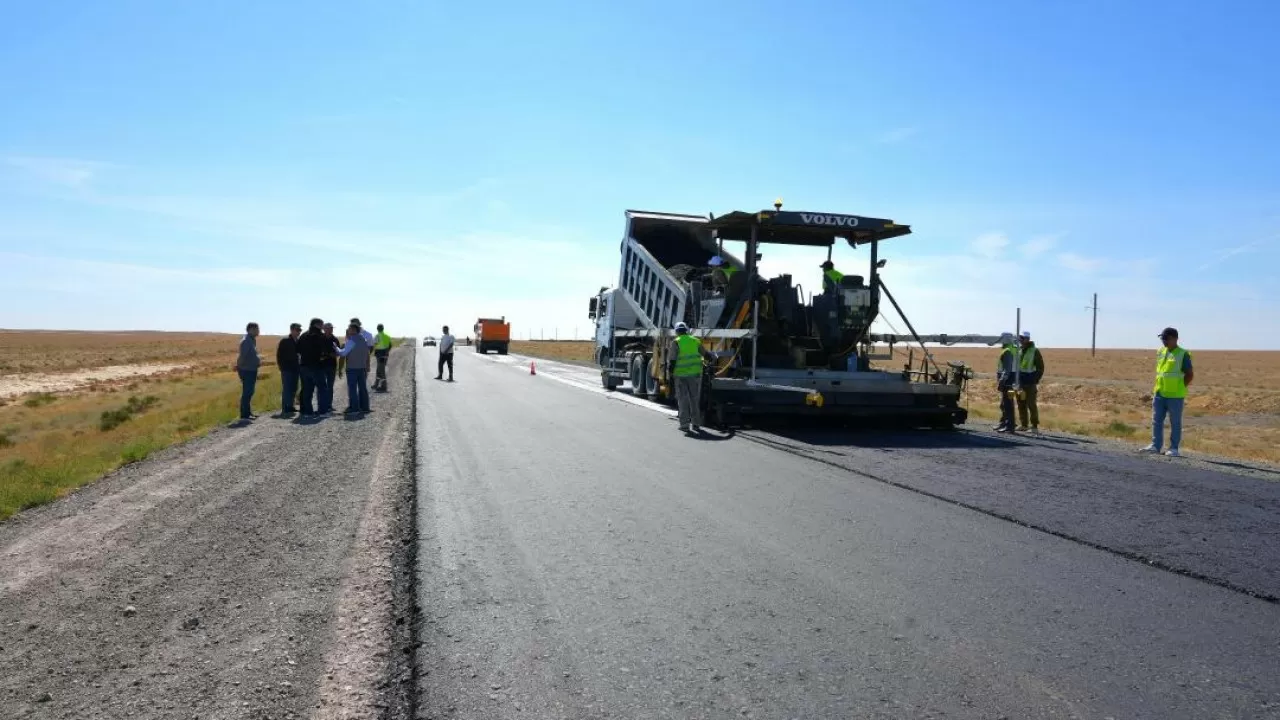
<box><xmin>0</xmin><ymin>0</ymin><xmax>1280</xmax><ymax>348</ymax></box>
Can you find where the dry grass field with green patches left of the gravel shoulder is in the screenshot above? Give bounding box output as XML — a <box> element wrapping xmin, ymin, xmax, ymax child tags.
<box><xmin>0</xmin><ymin>331</ymin><xmax>280</xmax><ymax>519</ymax></box>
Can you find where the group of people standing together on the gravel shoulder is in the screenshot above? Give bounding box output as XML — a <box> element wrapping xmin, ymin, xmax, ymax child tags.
<box><xmin>236</xmin><ymin>318</ymin><xmax>392</xmax><ymax>420</ymax></box>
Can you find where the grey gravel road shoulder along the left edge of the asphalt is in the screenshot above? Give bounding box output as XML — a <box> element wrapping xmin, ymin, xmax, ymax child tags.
<box><xmin>0</xmin><ymin>348</ymin><xmax>415</xmax><ymax>719</ymax></box>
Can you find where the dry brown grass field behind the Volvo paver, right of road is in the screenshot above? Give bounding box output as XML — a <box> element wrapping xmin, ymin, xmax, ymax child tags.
<box><xmin>511</xmin><ymin>342</ymin><xmax>1280</xmax><ymax>462</ymax></box>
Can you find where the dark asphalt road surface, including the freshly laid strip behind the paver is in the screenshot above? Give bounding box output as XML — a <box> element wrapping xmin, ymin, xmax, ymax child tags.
<box><xmin>417</xmin><ymin>348</ymin><xmax>1280</xmax><ymax>719</ymax></box>
